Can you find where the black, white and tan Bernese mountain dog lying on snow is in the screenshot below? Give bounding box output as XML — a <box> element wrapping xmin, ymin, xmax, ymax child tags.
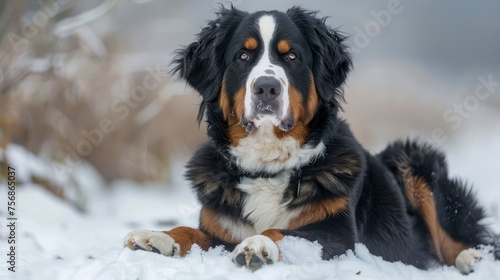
<box><xmin>124</xmin><ymin>7</ymin><xmax>500</xmax><ymax>273</ymax></box>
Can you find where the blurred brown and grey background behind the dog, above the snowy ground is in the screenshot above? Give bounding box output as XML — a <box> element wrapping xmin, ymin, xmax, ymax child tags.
<box><xmin>0</xmin><ymin>0</ymin><xmax>500</xmax><ymax>210</ymax></box>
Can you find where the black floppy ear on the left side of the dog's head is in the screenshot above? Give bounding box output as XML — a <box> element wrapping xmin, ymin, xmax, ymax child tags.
<box><xmin>172</xmin><ymin>6</ymin><xmax>247</xmax><ymax>121</ymax></box>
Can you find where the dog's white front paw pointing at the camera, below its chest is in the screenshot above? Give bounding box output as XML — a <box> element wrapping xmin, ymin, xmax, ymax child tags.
<box><xmin>233</xmin><ymin>235</ymin><xmax>280</xmax><ymax>271</ymax></box>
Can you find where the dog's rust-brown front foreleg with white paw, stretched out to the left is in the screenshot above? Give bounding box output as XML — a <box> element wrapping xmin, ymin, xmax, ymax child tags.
<box><xmin>123</xmin><ymin>227</ymin><xmax>212</xmax><ymax>256</ymax></box>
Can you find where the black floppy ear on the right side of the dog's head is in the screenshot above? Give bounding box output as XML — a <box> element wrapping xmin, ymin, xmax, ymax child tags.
<box><xmin>287</xmin><ymin>7</ymin><xmax>352</xmax><ymax>109</ymax></box>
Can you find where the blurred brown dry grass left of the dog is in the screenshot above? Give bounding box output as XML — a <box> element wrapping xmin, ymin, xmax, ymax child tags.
<box><xmin>0</xmin><ymin>1</ymin><xmax>205</xmax><ymax>186</ymax></box>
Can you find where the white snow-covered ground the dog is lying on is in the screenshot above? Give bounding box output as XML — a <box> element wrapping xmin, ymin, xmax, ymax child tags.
<box><xmin>0</xmin><ymin>137</ymin><xmax>500</xmax><ymax>280</ymax></box>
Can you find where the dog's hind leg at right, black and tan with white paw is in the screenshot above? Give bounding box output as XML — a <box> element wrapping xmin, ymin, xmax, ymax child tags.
<box><xmin>381</xmin><ymin>142</ymin><xmax>494</xmax><ymax>274</ymax></box>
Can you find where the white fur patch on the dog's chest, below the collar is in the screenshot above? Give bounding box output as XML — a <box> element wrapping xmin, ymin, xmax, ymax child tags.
<box><xmin>238</xmin><ymin>173</ymin><xmax>302</xmax><ymax>233</ymax></box>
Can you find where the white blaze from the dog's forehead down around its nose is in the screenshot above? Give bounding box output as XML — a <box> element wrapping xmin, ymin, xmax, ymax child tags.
<box><xmin>245</xmin><ymin>15</ymin><xmax>290</xmax><ymax>119</ymax></box>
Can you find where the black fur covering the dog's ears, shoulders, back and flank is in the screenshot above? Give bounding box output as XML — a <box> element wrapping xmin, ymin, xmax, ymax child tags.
<box><xmin>173</xmin><ymin>7</ymin><xmax>498</xmax><ymax>268</ymax></box>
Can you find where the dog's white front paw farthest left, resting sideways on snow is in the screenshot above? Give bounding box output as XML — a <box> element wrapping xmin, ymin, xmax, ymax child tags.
<box><xmin>123</xmin><ymin>230</ymin><xmax>180</xmax><ymax>256</ymax></box>
